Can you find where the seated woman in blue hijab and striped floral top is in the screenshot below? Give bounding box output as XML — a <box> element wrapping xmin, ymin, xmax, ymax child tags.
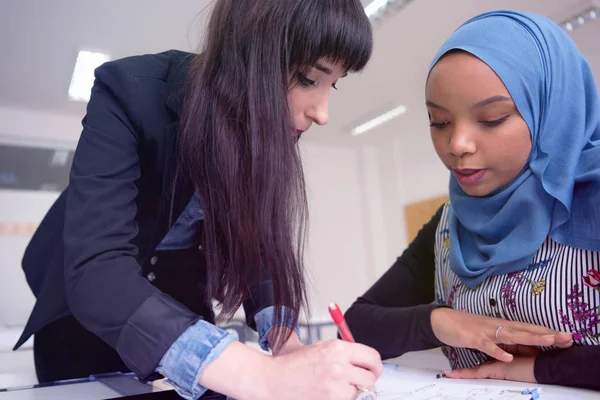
<box><xmin>347</xmin><ymin>11</ymin><xmax>600</xmax><ymax>389</ymax></box>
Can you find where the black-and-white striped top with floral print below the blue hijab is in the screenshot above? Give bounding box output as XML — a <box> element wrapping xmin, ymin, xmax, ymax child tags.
<box><xmin>435</xmin><ymin>204</ymin><xmax>600</xmax><ymax>369</ymax></box>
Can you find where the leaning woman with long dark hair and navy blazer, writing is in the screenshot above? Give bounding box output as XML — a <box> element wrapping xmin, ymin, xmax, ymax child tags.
<box><xmin>15</xmin><ymin>0</ymin><xmax>381</xmax><ymax>399</ymax></box>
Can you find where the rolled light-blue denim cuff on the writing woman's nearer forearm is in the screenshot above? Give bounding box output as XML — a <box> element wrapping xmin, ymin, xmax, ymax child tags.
<box><xmin>156</xmin><ymin>320</ymin><xmax>235</xmax><ymax>400</ymax></box>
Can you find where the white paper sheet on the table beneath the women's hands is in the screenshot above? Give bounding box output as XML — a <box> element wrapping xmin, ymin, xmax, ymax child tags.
<box><xmin>376</xmin><ymin>365</ymin><xmax>583</xmax><ymax>400</ymax></box>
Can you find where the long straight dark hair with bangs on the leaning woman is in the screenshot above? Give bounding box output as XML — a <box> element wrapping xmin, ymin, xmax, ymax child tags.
<box><xmin>179</xmin><ymin>0</ymin><xmax>372</xmax><ymax>345</ymax></box>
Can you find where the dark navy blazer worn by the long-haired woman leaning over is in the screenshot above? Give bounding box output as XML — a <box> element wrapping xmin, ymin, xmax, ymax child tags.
<box><xmin>15</xmin><ymin>50</ymin><xmax>273</xmax><ymax>379</ymax></box>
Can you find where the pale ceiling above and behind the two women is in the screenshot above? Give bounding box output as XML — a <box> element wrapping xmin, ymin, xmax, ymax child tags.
<box><xmin>0</xmin><ymin>0</ymin><xmax>600</xmax><ymax>147</ymax></box>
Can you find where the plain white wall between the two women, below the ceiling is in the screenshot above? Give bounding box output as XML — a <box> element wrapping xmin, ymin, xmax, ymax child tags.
<box><xmin>303</xmin><ymin>130</ymin><xmax>449</xmax><ymax>319</ymax></box>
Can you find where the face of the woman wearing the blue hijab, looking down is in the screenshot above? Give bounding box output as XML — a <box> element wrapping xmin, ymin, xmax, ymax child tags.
<box><xmin>426</xmin><ymin>51</ymin><xmax>531</xmax><ymax>196</ymax></box>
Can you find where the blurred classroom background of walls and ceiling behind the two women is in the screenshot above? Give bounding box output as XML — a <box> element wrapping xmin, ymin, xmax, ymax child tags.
<box><xmin>0</xmin><ymin>0</ymin><xmax>600</xmax><ymax>387</ymax></box>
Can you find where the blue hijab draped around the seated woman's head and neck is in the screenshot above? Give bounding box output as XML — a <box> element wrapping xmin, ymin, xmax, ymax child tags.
<box><xmin>430</xmin><ymin>11</ymin><xmax>600</xmax><ymax>288</ymax></box>
